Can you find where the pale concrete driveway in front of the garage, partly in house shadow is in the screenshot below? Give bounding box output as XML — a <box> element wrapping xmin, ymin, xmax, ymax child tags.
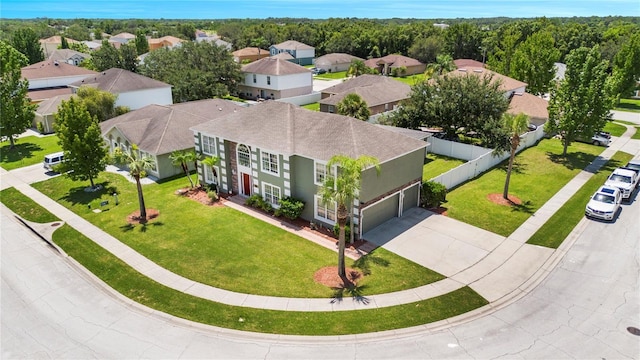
<box><xmin>363</xmin><ymin>208</ymin><xmax>506</xmax><ymax>277</ymax></box>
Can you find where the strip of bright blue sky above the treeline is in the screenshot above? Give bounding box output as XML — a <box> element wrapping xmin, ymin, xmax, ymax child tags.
<box><xmin>0</xmin><ymin>0</ymin><xmax>640</xmax><ymax>19</ymax></box>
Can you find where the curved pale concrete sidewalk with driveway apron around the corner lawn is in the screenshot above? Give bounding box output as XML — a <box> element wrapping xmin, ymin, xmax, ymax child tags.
<box><xmin>0</xmin><ymin>123</ymin><xmax>632</xmax><ymax>311</ymax></box>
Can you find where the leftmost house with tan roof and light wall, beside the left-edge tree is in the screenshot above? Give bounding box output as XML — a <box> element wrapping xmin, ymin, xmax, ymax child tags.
<box><xmin>21</xmin><ymin>60</ymin><xmax>97</xmax><ymax>102</ymax></box>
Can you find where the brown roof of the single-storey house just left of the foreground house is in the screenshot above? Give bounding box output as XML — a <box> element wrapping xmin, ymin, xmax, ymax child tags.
<box><xmin>100</xmin><ymin>99</ymin><xmax>242</xmax><ymax>155</ymax></box>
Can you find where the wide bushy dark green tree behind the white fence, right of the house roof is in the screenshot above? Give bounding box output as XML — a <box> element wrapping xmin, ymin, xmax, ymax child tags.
<box><xmin>390</xmin><ymin>72</ymin><xmax>509</xmax><ymax>148</ymax></box>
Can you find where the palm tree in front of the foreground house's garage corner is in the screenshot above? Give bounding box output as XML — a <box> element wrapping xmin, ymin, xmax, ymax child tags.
<box><xmin>318</xmin><ymin>155</ymin><xmax>380</xmax><ymax>279</ymax></box>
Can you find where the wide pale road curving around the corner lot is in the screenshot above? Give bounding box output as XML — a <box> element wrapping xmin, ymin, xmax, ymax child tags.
<box><xmin>0</xmin><ymin>184</ymin><xmax>640</xmax><ymax>359</ymax></box>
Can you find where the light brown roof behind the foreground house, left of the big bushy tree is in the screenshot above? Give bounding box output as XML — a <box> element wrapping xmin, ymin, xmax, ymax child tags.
<box><xmin>320</xmin><ymin>79</ymin><xmax>411</xmax><ymax>107</ymax></box>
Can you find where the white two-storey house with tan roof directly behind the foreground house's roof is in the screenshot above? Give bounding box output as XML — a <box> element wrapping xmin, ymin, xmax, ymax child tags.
<box><xmin>238</xmin><ymin>57</ymin><xmax>313</xmax><ymax>99</ymax></box>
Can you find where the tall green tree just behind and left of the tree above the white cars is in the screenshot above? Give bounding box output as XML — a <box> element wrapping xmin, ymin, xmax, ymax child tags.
<box><xmin>506</xmin><ymin>32</ymin><xmax>560</xmax><ymax>95</ymax></box>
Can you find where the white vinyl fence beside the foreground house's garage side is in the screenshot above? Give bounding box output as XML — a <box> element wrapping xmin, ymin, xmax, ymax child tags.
<box><xmin>427</xmin><ymin>126</ymin><xmax>544</xmax><ymax>189</ymax></box>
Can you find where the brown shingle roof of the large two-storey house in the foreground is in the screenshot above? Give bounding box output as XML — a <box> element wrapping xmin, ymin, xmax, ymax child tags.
<box><xmin>191</xmin><ymin>101</ymin><xmax>426</xmax><ymax>163</ymax></box>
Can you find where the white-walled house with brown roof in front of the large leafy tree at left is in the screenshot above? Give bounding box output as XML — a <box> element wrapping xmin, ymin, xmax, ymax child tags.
<box><xmin>69</xmin><ymin>68</ymin><xmax>173</xmax><ymax>110</ymax></box>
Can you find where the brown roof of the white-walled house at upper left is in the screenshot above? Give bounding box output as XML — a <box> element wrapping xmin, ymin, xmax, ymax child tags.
<box><xmin>69</xmin><ymin>68</ymin><xmax>171</xmax><ymax>94</ymax></box>
